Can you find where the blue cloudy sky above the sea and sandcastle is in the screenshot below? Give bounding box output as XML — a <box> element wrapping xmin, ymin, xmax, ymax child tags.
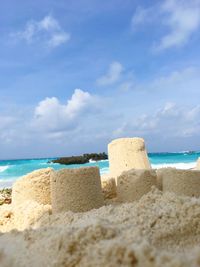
<box><xmin>0</xmin><ymin>0</ymin><xmax>200</xmax><ymax>159</ymax></box>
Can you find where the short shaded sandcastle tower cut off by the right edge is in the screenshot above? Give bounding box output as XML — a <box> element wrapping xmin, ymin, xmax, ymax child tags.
<box><xmin>162</xmin><ymin>168</ymin><xmax>200</xmax><ymax>197</ymax></box>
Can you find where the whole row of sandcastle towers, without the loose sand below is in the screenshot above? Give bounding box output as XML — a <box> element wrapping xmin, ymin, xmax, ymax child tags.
<box><xmin>12</xmin><ymin>138</ymin><xmax>200</xmax><ymax>212</ymax></box>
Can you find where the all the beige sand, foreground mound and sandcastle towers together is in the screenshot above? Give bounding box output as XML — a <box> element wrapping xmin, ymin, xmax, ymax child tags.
<box><xmin>0</xmin><ymin>138</ymin><xmax>200</xmax><ymax>267</ymax></box>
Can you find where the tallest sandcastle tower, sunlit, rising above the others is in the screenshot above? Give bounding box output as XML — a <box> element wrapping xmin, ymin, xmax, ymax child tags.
<box><xmin>108</xmin><ymin>138</ymin><xmax>151</xmax><ymax>178</ymax></box>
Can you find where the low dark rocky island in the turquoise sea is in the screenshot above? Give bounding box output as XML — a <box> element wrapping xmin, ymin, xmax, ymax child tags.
<box><xmin>51</xmin><ymin>152</ymin><xmax>108</xmax><ymax>165</ymax></box>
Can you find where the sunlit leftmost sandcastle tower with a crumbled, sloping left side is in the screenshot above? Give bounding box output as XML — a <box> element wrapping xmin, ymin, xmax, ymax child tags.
<box><xmin>12</xmin><ymin>168</ymin><xmax>54</xmax><ymax>205</ymax></box>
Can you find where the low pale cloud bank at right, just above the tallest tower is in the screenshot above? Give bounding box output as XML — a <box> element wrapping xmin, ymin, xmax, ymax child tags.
<box><xmin>113</xmin><ymin>102</ymin><xmax>200</xmax><ymax>140</ymax></box>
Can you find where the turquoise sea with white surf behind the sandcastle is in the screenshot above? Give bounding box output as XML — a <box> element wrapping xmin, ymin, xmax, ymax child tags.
<box><xmin>0</xmin><ymin>151</ymin><xmax>200</xmax><ymax>188</ymax></box>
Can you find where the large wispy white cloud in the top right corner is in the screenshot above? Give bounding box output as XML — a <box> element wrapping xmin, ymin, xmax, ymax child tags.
<box><xmin>131</xmin><ymin>0</ymin><xmax>200</xmax><ymax>51</ymax></box>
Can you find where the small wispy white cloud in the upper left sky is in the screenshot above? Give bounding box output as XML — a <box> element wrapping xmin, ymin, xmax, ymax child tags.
<box><xmin>11</xmin><ymin>15</ymin><xmax>70</xmax><ymax>48</ymax></box>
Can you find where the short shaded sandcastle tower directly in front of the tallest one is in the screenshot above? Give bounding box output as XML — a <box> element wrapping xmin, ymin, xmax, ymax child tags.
<box><xmin>117</xmin><ymin>169</ymin><xmax>157</xmax><ymax>202</ymax></box>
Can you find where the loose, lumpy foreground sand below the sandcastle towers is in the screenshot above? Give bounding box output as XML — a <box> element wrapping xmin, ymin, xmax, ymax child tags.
<box><xmin>0</xmin><ymin>188</ymin><xmax>200</xmax><ymax>267</ymax></box>
